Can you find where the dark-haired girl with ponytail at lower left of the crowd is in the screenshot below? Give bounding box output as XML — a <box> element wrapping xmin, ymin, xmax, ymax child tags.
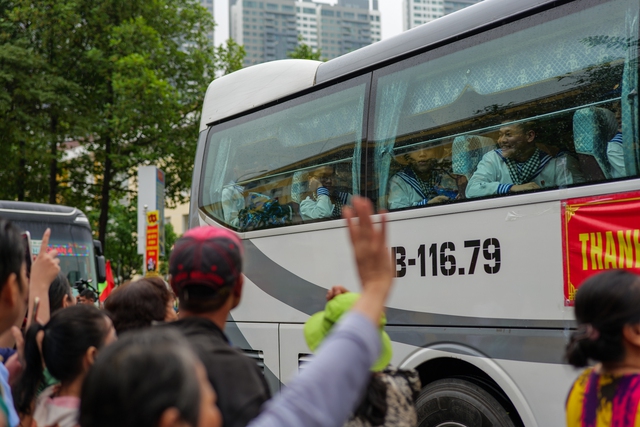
<box><xmin>13</xmin><ymin>305</ymin><xmax>116</xmax><ymax>427</ymax></box>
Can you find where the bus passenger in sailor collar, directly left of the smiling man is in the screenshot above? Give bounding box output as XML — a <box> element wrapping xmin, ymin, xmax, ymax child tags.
<box><xmin>389</xmin><ymin>147</ymin><xmax>458</xmax><ymax>209</ymax></box>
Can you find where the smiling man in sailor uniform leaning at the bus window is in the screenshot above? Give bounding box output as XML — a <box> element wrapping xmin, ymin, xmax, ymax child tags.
<box><xmin>466</xmin><ymin>122</ymin><xmax>584</xmax><ymax>198</ymax></box>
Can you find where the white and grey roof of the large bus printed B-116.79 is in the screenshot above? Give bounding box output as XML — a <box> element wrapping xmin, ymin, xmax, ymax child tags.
<box><xmin>200</xmin><ymin>0</ymin><xmax>556</xmax><ymax>132</ymax></box>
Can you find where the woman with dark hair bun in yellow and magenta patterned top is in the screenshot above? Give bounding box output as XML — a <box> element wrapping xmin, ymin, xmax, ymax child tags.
<box><xmin>565</xmin><ymin>270</ymin><xmax>640</xmax><ymax>427</ymax></box>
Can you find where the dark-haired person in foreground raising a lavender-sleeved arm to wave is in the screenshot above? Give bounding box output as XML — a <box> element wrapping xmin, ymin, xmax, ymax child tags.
<box><xmin>79</xmin><ymin>197</ymin><xmax>393</xmax><ymax>427</ymax></box>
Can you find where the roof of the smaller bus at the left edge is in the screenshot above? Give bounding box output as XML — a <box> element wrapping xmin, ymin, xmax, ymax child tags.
<box><xmin>0</xmin><ymin>200</ymin><xmax>89</xmax><ymax>228</ymax></box>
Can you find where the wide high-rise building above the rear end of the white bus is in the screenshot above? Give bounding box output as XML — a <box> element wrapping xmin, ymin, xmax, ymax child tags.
<box><xmin>229</xmin><ymin>0</ymin><xmax>380</xmax><ymax>65</ymax></box>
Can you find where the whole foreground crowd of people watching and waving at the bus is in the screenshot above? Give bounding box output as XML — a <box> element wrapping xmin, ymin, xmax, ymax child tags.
<box><xmin>0</xmin><ymin>198</ymin><xmax>640</xmax><ymax>427</ymax></box>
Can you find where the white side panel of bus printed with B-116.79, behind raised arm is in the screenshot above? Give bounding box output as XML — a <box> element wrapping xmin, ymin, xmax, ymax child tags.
<box><xmin>234</xmin><ymin>199</ymin><xmax>573</xmax><ymax>327</ymax></box>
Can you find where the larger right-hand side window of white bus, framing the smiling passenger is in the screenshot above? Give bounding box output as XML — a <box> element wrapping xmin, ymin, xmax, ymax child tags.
<box><xmin>371</xmin><ymin>0</ymin><xmax>640</xmax><ymax>209</ymax></box>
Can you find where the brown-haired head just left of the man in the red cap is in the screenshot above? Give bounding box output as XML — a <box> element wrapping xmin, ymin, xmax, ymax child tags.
<box><xmin>104</xmin><ymin>277</ymin><xmax>177</xmax><ymax>335</ymax></box>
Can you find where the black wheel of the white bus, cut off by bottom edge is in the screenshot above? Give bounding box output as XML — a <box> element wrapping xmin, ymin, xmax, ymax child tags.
<box><xmin>416</xmin><ymin>378</ymin><xmax>514</xmax><ymax>427</ymax></box>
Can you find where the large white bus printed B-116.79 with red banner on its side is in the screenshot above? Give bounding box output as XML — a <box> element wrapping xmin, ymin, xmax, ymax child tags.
<box><xmin>190</xmin><ymin>0</ymin><xmax>640</xmax><ymax>427</ymax></box>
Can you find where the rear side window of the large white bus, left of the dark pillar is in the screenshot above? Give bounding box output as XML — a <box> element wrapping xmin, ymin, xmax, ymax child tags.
<box><xmin>200</xmin><ymin>76</ymin><xmax>368</xmax><ymax>231</ymax></box>
